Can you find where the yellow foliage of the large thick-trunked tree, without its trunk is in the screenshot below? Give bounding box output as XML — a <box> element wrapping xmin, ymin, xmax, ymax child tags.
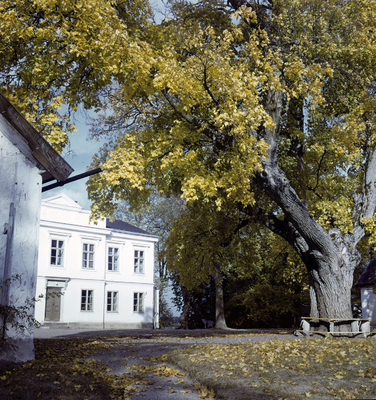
<box><xmin>84</xmin><ymin>0</ymin><xmax>376</xmax><ymax>238</ymax></box>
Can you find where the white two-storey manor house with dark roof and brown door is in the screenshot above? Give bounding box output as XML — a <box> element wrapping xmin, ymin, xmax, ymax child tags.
<box><xmin>35</xmin><ymin>194</ymin><xmax>159</xmax><ymax>329</ymax></box>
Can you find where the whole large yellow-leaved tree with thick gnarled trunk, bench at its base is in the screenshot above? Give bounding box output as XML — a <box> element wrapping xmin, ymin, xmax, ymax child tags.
<box><xmin>89</xmin><ymin>0</ymin><xmax>376</xmax><ymax>330</ymax></box>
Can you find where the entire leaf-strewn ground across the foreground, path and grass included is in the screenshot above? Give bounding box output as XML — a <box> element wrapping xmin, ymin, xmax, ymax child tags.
<box><xmin>0</xmin><ymin>331</ymin><xmax>376</xmax><ymax>400</ymax></box>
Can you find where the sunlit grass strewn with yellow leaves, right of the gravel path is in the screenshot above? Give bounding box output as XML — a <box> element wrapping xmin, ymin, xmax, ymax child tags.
<box><xmin>168</xmin><ymin>338</ymin><xmax>376</xmax><ymax>400</ymax></box>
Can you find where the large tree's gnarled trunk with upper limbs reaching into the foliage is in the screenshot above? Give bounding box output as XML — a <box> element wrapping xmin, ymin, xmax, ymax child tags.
<box><xmin>250</xmin><ymin>65</ymin><xmax>376</xmax><ymax>332</ymax></box>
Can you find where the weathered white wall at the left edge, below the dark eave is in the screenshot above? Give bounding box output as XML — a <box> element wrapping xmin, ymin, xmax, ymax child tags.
<box><xmin>0</xmin><ymin>116</ymin><xmax>42</xmax><ymax>362</ymax></box>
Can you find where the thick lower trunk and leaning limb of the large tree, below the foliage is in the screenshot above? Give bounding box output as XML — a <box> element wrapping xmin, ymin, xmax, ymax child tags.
<box><xmin>256</xmin><ymin>161</ymin><xmax>361</xmax><ymax>332</ymax></box>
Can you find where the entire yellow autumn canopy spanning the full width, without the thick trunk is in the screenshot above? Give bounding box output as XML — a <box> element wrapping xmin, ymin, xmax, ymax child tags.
<box><xmin>0</xmin><ymin>0</ymin><xmax>376</xmax><ymax>247</ymax></box>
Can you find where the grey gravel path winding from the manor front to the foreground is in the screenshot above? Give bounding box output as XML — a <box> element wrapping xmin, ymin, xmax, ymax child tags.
<box><xmin>34</xmin><ymin>329</ymin><xmax>295</xmax><ymax>400</ymax></box>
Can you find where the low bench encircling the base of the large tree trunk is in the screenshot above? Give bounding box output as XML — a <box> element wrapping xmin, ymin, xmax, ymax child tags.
<box><xmin>295</xmin><ymin>317</ymin><xmax>372</xmax><ymax>337</ymax></box>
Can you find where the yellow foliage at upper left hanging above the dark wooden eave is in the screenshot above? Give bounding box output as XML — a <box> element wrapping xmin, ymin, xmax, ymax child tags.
<box><xmin>0</xmin><ymin>0</ymin><xmax>151</xmax><ymax>151</ymax></box>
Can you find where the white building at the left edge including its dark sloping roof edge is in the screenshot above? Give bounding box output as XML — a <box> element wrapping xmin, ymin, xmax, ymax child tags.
<box><xmin>0</xmin><ymin>93</ymin><xmax>73</xmax><ymax>362</ymax></box>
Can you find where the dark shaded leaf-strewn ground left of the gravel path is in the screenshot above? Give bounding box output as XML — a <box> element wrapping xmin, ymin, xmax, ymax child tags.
<box><xmin>0</xmin><ymin>339</ymin><xmax>137</xmax><ymax>400</ymax></box>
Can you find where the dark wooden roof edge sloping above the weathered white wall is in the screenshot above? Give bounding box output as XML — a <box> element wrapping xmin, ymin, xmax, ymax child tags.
<box><xmin>0</xmin><ymin>93</ymin><xmax>73</xmax><ymax>182</ymax></box>
